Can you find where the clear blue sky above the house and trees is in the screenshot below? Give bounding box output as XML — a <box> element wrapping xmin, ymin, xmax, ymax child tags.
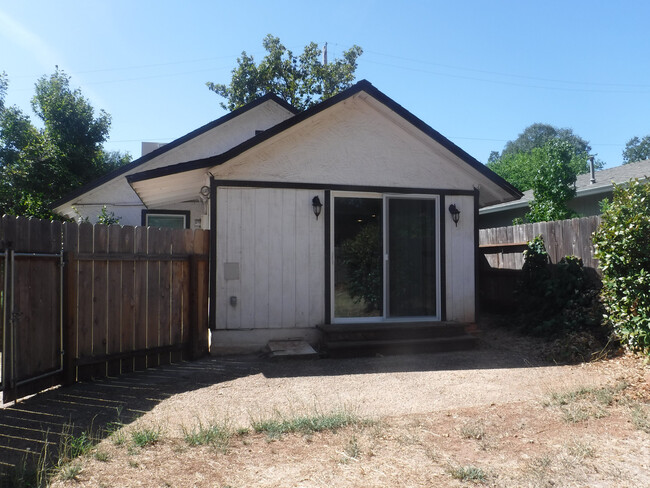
<box><xmin>0</xmin><ymin>0</ymin><xmax>650</xmax><ymax>167</ymax></box>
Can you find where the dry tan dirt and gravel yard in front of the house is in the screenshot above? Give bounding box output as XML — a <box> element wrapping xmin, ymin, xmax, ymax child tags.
<box><xmin>10</xmin><ymin>322</ymin><xmax>650</xmax><ymax>488</ymax></box>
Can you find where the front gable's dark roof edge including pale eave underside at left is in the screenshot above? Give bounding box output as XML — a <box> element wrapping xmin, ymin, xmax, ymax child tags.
<box><xmin>127</xmin><ymin>80</ymin><xmax>521</xmax><ymax>205</ymax></box>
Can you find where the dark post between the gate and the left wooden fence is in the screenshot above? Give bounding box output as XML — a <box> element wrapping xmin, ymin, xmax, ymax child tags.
<box><xmin>62</xmin><ymin>251</ymin><xmax>77</xmax><ymax>385</ymax></box>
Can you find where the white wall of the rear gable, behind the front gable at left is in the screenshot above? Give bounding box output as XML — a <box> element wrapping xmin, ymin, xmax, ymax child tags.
<box><xmin>55</xmin><ymin>101</ymin><xmax>293</xmax><ymax>225</ymax></box>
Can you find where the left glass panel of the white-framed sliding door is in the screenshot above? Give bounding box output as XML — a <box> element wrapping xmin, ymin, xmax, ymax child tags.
<box><xmin>333</xmin><ymin>196</ymin><xmax>384</xmax><ymax>319</ymax></box>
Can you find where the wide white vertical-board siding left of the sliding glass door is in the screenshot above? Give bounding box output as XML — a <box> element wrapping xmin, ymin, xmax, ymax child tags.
<box><xmin>213</xmin><ymin>187</ymin><xmax>325</xmax><ymax>349</ymax></box>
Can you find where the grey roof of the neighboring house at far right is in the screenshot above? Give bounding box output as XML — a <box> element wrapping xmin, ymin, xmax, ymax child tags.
<box><xmin>479</xmin><ymin>159</ymin><xmax>650</xmax><ymax>215</ymax></box>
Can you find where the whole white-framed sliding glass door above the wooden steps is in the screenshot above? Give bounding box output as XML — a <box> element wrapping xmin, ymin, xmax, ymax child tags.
<box><xmin>332</xmin><ymin>193</ymin><xmax>440</xmax><ymax>322</ymax></box>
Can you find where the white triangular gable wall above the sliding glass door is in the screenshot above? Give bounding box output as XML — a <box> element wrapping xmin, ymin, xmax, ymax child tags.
<box><xmin>210</xmin><ymin>94</ymin><xmax>504</xmax><ymax>205</ymax></box>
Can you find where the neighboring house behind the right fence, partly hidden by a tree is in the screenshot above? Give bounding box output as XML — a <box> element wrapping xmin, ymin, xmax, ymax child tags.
<box><xmin>479</xmin><ymin>159</ymin><xmax>650</xmax><ymax>229</ymax></box>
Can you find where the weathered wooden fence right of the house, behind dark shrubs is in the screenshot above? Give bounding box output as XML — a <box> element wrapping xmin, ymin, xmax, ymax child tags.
<box><xmin>479</xmin><ymin>216</ymin><xmax>600</xmax><ymax>311</ymax></box>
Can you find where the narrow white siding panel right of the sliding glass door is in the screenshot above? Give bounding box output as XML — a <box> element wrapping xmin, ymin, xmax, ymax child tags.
<box><xmin>445</xmin><ymin>196</ymin><xmax>476</xmax><ymax>322</ymax></box>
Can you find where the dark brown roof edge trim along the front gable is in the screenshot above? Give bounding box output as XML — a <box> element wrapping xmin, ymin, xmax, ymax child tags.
<box><xmin>127</xmin><ymin>80</ymin><xmax>522</xmax><ymax>204</ymax></box>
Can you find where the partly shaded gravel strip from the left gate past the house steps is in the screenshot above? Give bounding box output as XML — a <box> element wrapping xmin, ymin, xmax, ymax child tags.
<box><xmin>0</xmin><ymin>322</ymin><xmax>628</xmax><ymax>474</ymax></box>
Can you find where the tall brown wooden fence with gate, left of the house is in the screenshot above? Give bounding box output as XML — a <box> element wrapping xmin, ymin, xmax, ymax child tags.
<box><xmin>0</xmin><ymin>216</ymin><xmax>209</xmax><ymax>402</ymax></box>
